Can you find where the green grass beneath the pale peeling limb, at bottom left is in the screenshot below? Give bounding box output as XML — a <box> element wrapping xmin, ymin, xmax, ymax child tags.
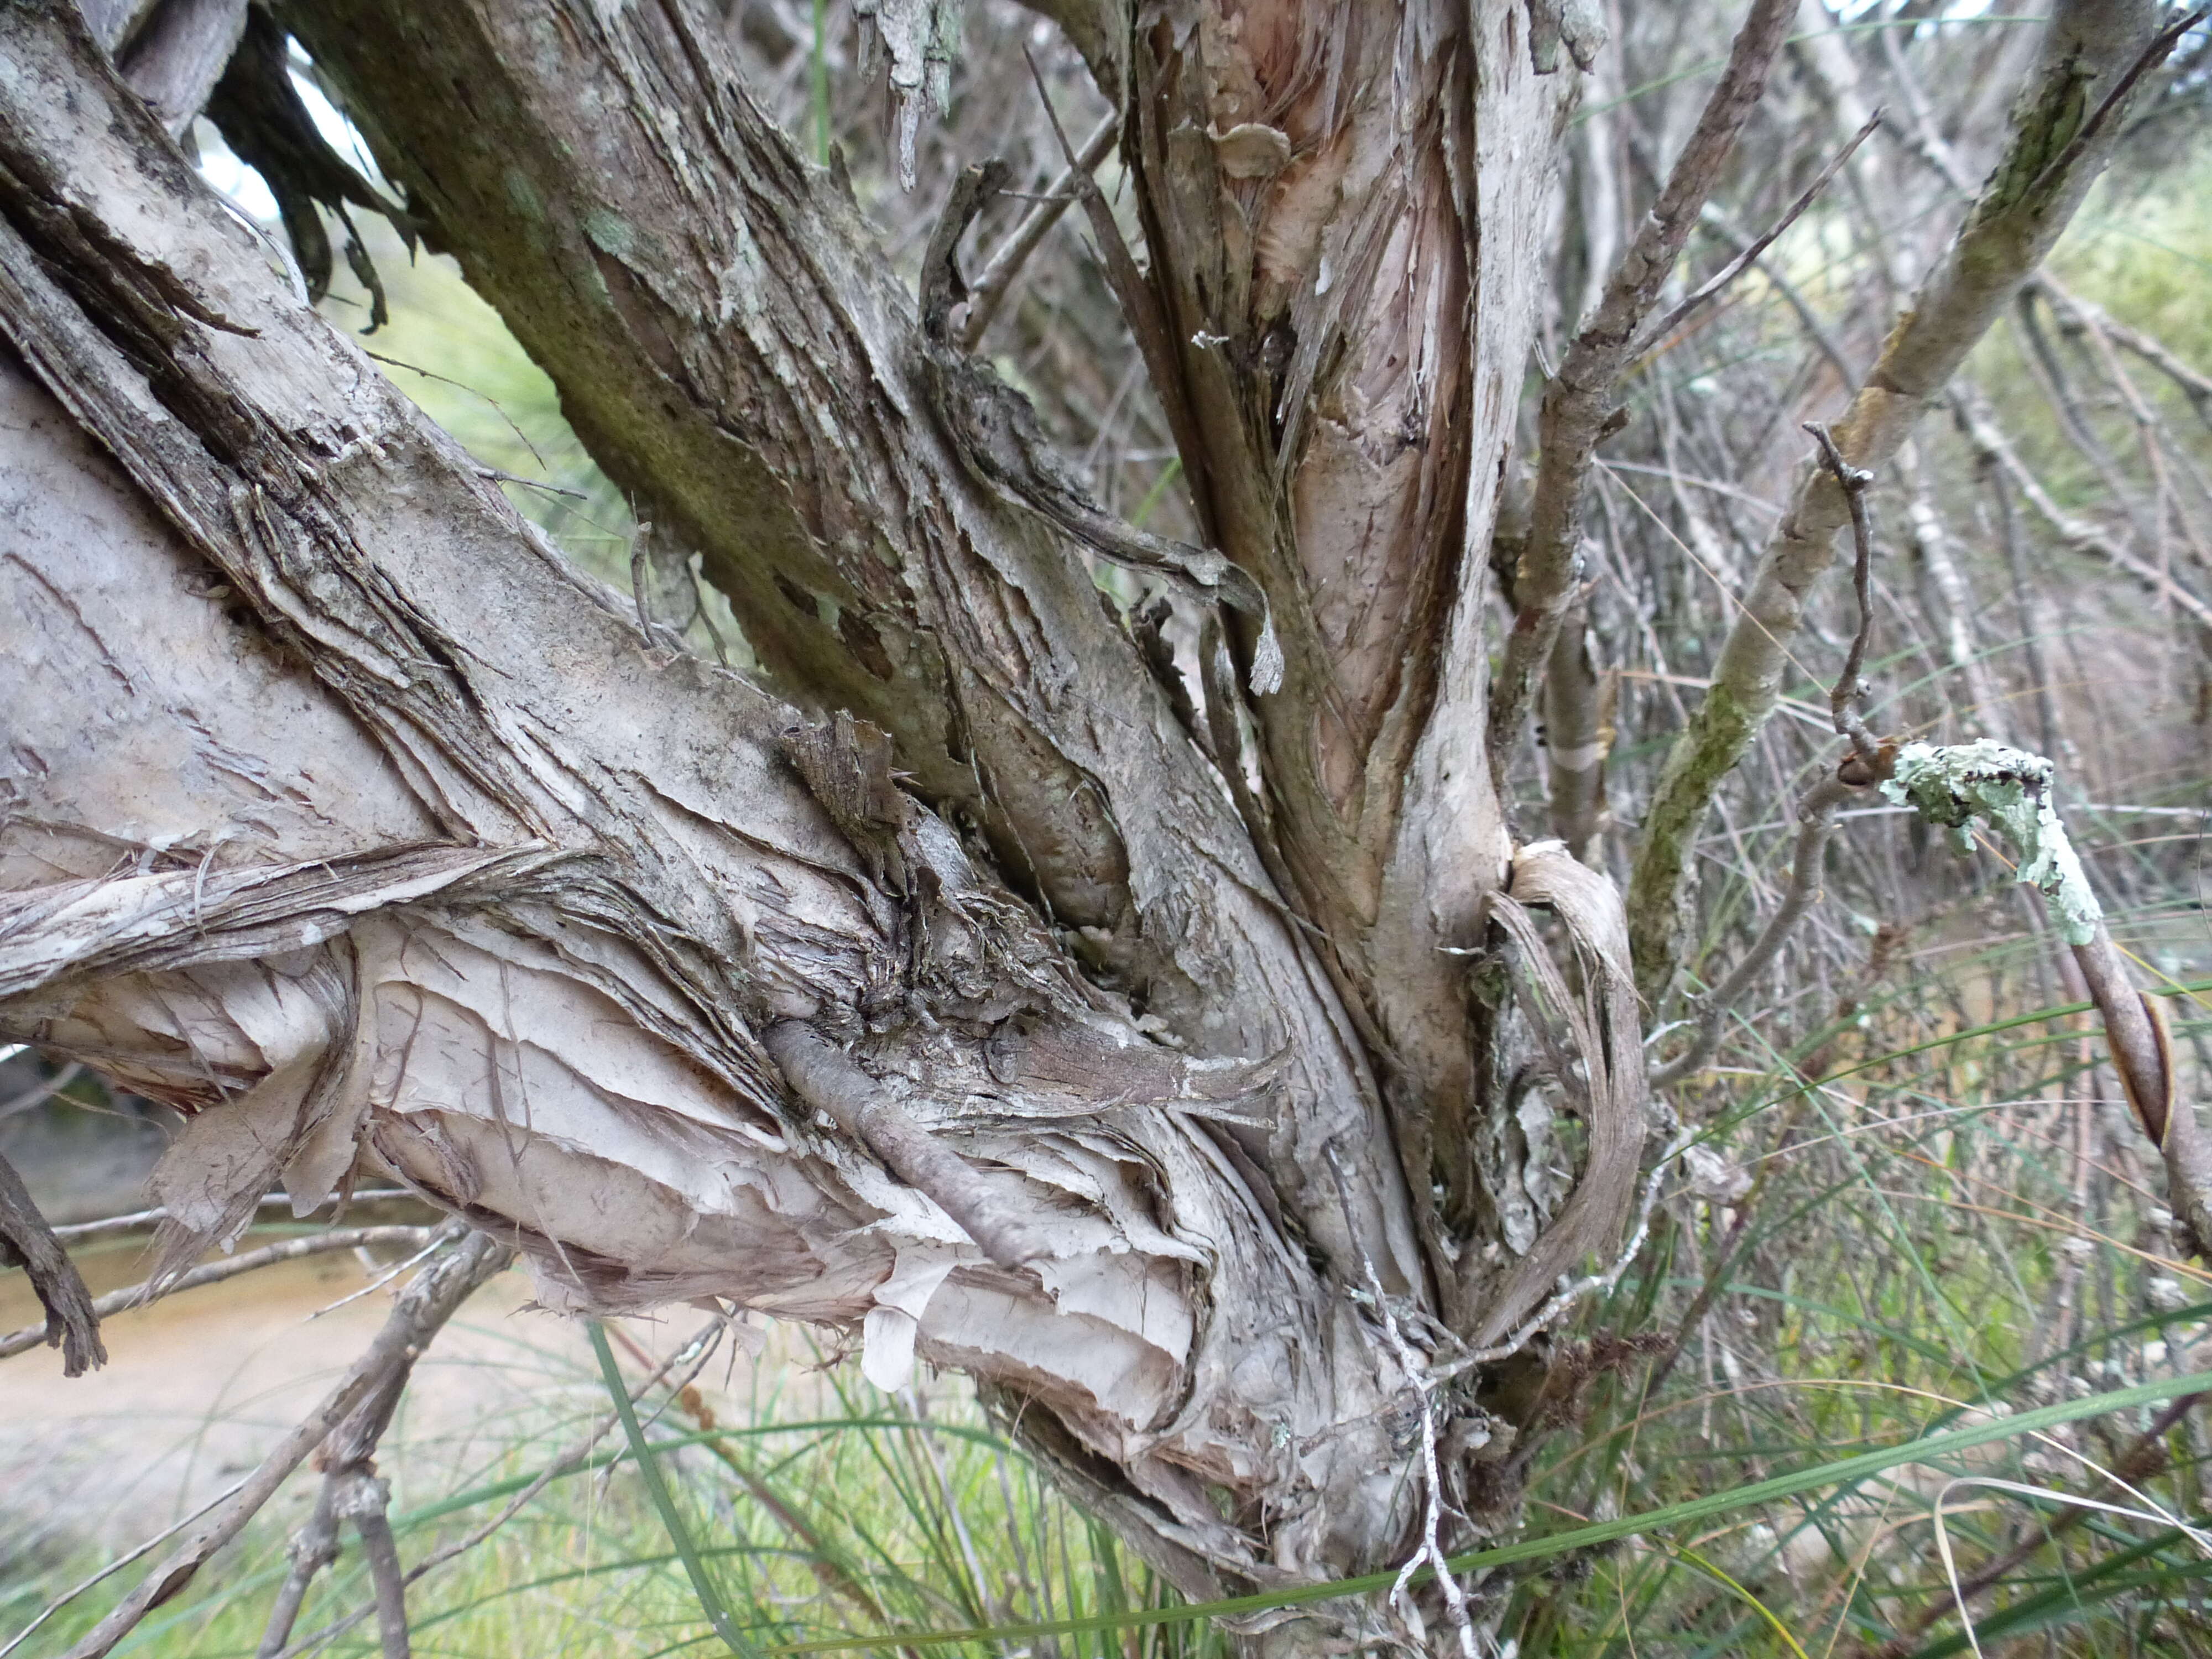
<box><xmin>0</xmin><ymin>1310</ymin><xmax>1225</xmax><ymax>1659</ymax></box>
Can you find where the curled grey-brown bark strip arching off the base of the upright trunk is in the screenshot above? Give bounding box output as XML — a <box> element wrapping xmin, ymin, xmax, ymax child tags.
<box><xmin>1473</xmin><ymin>841</ymin><xmax>1646</xmax><ymax>1347</ymax></box>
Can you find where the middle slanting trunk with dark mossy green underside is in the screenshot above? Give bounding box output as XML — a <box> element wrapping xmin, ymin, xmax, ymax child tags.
<box><xmin>272</xmin><ymin>0</ymin><xmax>1422</xmax><ymax>1292</ymax></box>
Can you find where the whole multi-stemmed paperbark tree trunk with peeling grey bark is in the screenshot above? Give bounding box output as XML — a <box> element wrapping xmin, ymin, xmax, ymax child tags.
<box><xmin>0</xmin><ymin>0</ymin><xmax>1610</xmax><ymax>1635</ymax></box>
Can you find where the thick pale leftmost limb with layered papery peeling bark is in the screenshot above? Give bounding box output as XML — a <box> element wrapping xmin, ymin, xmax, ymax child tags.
<box><xmin>0</xmin><ymin>9</ymin><xmax>1511</xmax><ymax>1595</ymax></box>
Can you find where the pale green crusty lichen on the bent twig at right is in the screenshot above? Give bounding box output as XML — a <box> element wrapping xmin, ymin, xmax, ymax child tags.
<box><xmin>1882</xmin><ymin>737</ymin><xmax>2104</xmax><ymax>945</ymax></box>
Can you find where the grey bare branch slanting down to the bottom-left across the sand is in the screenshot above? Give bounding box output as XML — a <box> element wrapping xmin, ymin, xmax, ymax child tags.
<box><xmin>69</xmin><ymin>1232</ymin><xmax>513</xmax><ymax>1659</ymax></box>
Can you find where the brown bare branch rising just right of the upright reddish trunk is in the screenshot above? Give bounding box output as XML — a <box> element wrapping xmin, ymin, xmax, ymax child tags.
<box><xmin>1489</xmin><ymin>0</ymin><xmax>1796</xmax><ymax>783</ymax></box>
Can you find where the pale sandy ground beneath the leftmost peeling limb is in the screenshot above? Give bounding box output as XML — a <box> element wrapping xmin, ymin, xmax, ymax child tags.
<box><xmin>0</xmin><ymin>1241</ymin><xmax>796</xmax><ymax>1577</ymax></box>
